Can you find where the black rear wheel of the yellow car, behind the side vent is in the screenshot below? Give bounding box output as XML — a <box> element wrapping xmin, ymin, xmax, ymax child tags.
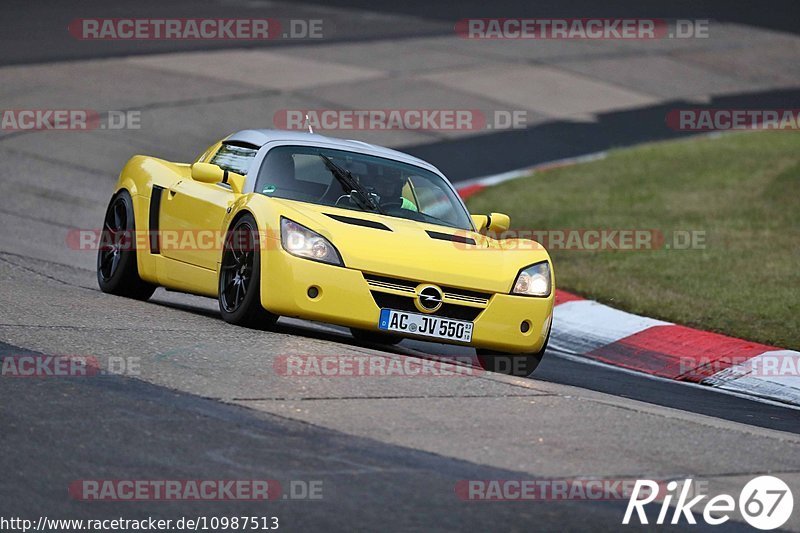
<box><xmin>97</xmin><ymin>190</ymin><xmax>156</xmax><ymax>300</ymax></box>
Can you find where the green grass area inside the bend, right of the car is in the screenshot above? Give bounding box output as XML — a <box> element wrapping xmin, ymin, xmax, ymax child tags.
<box><xmin>468</xmin><ymin>131</ymin><xmax>800</xmax><ymax>349</ymax></box>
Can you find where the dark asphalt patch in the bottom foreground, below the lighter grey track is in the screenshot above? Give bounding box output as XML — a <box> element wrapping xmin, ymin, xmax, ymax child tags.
<box><xmin>0</xmin><ymin>345</ymin><xmax>648</xmax><ymax>531</ymax></box>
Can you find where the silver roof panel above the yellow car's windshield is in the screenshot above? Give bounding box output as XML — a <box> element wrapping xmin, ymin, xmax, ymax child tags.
<box><xmin>225</xmin><ymin>129</ymin><xmax>443</xmax><ymax>175</ymax></box>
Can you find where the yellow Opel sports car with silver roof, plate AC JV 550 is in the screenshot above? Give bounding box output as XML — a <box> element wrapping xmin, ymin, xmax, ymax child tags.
<box><xmin>97</xmin><ymin>130</ymin><xmax>555</xmax><ymax>375</ymax></box>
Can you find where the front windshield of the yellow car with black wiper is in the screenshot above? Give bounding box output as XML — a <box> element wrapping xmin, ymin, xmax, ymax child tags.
<box><xmin>255</xmin><ymin>146</ymin><xmax>472</xmax><ymax>230</ymax></box>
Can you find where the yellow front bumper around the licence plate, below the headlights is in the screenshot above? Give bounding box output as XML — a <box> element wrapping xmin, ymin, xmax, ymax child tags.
<box><xmin>261</xmin><ymin>243</ymin><xmax>555</xmax><ymax>353</ymax></box>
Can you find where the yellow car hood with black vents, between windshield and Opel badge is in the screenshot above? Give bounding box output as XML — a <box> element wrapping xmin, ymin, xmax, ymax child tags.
<box><xmin>272</xmin><ymin>198</ymin><xmax>549</xmax><ymax>293</ymax></box>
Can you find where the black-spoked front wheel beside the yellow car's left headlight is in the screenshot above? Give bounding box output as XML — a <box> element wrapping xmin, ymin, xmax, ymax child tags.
<box><xmin>218</xmin><ymin>214</ymin><xmax>278</xmax><ymax>329</ymax></box>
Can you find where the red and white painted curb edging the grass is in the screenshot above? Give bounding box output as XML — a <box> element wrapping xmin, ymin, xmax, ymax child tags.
<box><xmin>458</xmin><ymin>156</ymin><xmax>800</xmax><ymax>406</ymax></box>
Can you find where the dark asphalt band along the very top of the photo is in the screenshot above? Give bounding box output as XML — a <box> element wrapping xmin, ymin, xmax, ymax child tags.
<box><xmin>0</xmin><ymin>0</ymin><xmax>798</xmax><ymax>65</ymax></box>
